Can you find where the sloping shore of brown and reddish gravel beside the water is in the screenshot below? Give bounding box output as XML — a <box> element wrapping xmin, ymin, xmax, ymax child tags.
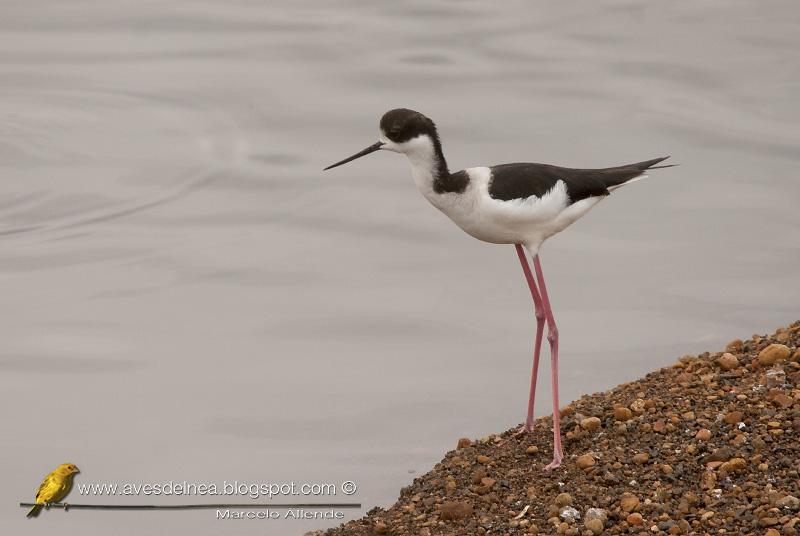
<box><xmin>318</xmin><ymin>321</ymin><xmax>800</xmax><ymax>536</ymax></box>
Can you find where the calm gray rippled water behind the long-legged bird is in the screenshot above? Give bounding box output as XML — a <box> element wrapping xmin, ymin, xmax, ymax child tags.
<box><xmin>0</xmin><ymin>0</ymin><xmax>800</xmax><ymax>536</ymax></box>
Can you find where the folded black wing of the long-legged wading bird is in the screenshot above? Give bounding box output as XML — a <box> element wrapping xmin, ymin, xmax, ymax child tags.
<box><xmin>489</xmin><ymin>157</ymin><xmax>668</xmax><ymax>203</ymax></box>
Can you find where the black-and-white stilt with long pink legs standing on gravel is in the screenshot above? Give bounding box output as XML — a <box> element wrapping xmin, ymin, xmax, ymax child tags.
<box><xmin>325</xmin><ymin>108</ymin><xmax>671</xmax><ymax>469</ymax></box>
